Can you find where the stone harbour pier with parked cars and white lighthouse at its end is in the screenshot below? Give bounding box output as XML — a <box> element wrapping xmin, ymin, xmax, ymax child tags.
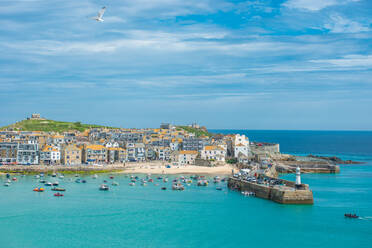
<box><xmin>228</xmin><ymin>177</ymin><xmax>314</xmax><ymax>204</ymax></box>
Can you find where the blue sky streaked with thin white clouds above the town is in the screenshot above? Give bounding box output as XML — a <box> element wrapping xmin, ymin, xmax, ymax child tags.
<box><xmin>0</xmin><ymin>0</ymin><xmax>372</xmax><ymax>130</ymax></box>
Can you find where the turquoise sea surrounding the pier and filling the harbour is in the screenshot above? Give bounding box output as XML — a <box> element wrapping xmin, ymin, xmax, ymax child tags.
<box><xmin>0</xmin><ymin>130</ymin><xmax>372</xmax><ymax>248</ymax></box>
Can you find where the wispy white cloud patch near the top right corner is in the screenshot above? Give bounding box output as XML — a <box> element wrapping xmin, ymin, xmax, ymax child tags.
<box><xmin>324</xmin><ymin>15</ymin><xmax>370</xmax><ymax>33</ymax></box>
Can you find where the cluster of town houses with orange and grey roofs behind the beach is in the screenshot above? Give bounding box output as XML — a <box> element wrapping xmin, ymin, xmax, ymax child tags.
<box><xmin>0</xmin><ymin>117</ymin><xmax>279</xmax><ymax>165</ymax></box>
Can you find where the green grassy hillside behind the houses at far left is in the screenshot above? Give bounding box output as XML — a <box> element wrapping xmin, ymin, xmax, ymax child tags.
<box><xmin>0</xmin><ymin>120</ymin><xmax>117</xmax><ymax>132</ymax></box>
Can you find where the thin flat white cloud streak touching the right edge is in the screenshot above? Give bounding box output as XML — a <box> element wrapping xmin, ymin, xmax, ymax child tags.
<box><xmin>310</xmin><ymin>55</ymin><xmax>372</xmax><ymax>67</ymax></box>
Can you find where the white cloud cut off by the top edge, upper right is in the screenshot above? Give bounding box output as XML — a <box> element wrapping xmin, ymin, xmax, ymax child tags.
<box><xmin>283</xmin><ymin>0</ymin><xmax>359</xmax><ymax>11</ymax></box>
